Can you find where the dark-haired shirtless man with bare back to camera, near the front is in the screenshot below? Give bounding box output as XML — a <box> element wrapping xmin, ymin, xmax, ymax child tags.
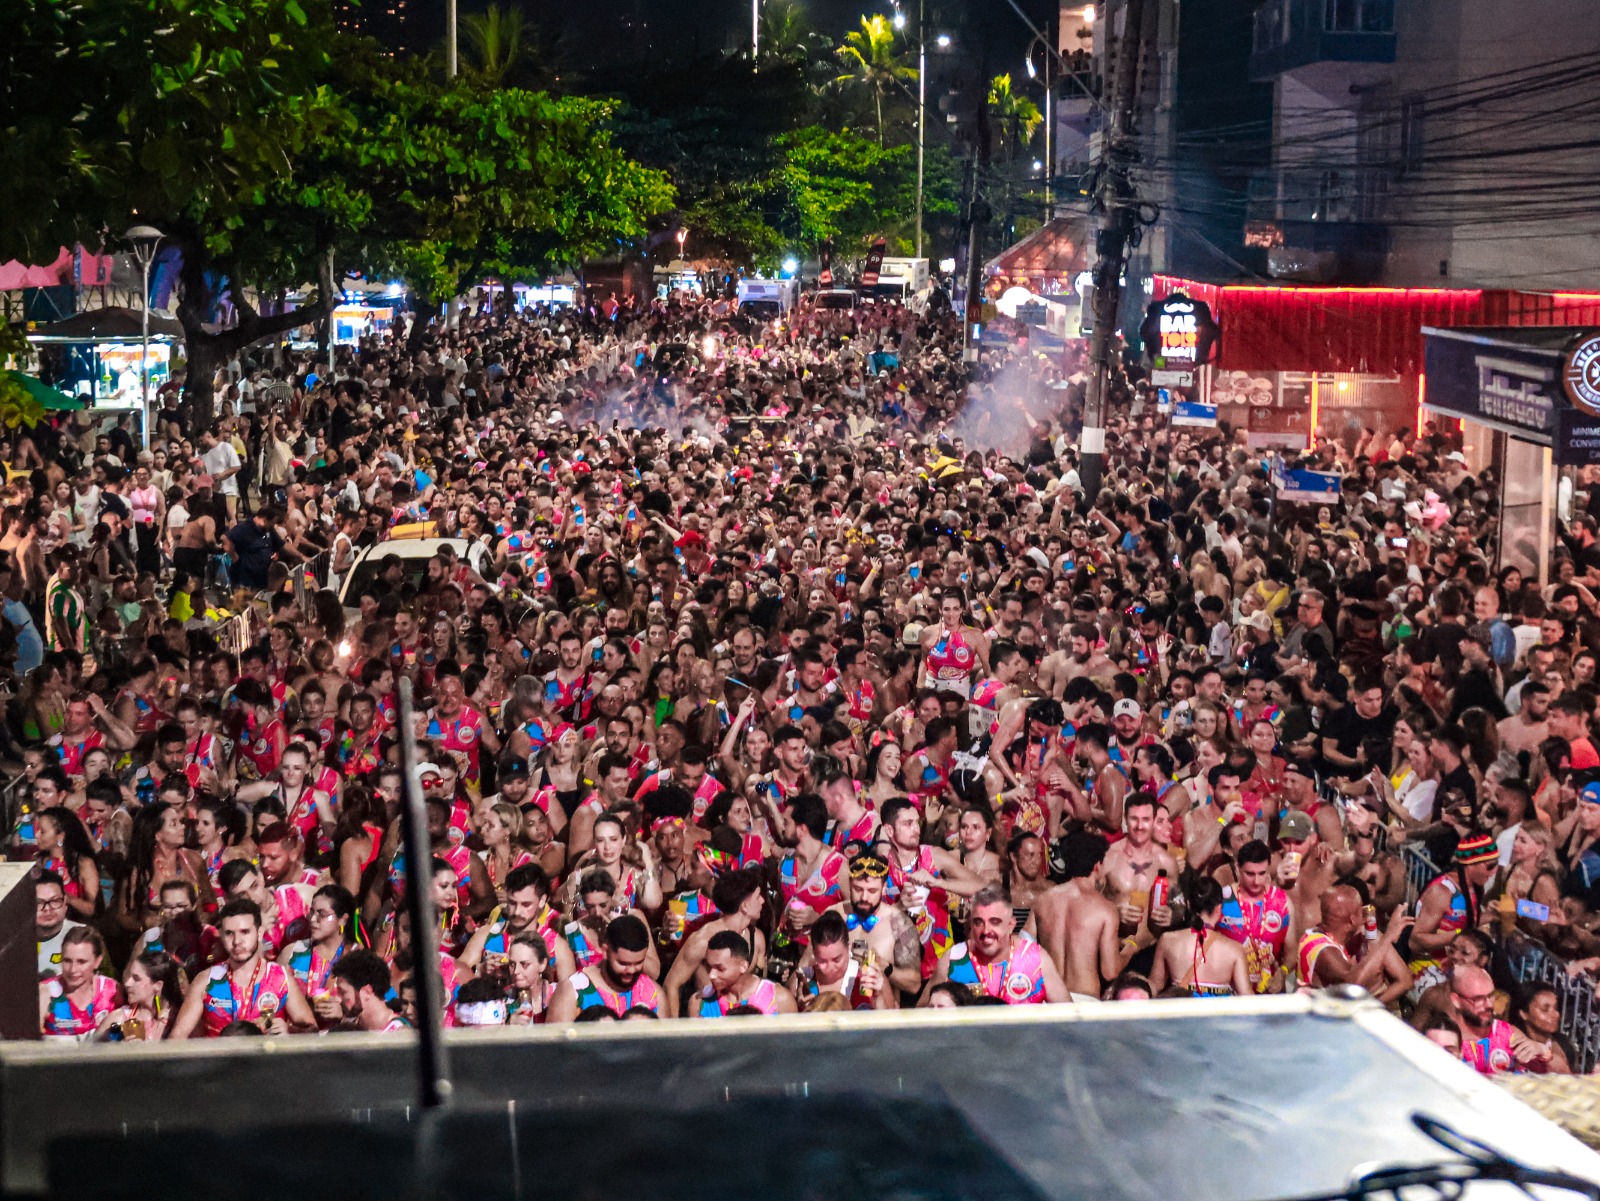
<box><xmin>1024</xmin><ymin>830</ymin><xmax>1131</xmax><ymax>998</ymax></box>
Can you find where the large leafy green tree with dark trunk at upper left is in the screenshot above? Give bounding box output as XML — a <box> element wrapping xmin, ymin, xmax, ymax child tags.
<box><xmin>0</xmin><ymin>0</ymin><xmax>672</xmax><ymax>421</ymax></box>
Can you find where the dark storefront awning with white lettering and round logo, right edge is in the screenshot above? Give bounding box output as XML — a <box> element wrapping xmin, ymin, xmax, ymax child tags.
<box><xmin>1422</xmin><ymin>326</ymin><xmax>1600</xmax><ymax>467</ymax></box>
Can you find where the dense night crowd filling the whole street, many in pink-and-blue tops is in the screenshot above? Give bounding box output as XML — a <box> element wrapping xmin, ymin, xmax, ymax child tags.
<box><xmin>0</xmin><ymin>284</ymin><xmax>1600</xmax><ymax>1073</ymax></box>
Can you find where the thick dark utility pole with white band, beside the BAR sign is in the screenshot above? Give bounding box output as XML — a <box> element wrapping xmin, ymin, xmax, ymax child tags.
<box><xmin>1078</xmin><ymin>0</ymin><xmax>1155</xmax><ymax>504</ymax></box>
